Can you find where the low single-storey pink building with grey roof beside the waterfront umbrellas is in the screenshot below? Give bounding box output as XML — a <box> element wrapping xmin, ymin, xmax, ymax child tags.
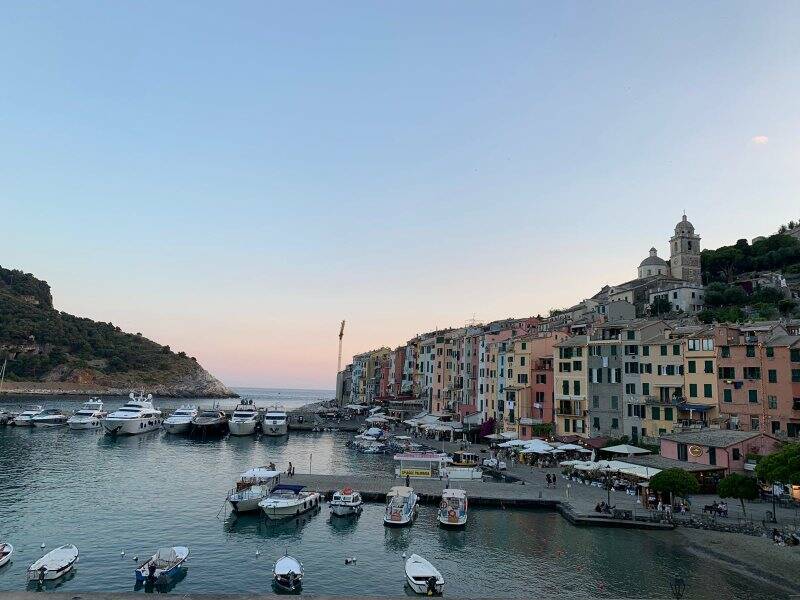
<box><xmin>661</xmin><ymin>429</ymin><xmax>780</xmax><ymax>474</ymax></box>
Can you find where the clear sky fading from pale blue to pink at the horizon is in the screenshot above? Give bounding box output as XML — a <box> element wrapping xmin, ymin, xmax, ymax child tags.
<box><xmin>0</xmin><ymin>0</ymin><xmax>800</xmax><ymax>389</ymax></box>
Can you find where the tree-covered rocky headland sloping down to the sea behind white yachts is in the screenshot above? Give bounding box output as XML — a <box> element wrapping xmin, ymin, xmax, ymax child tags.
<box><xmin>0</xmin><ymin>267</ymin><xmax>233</xmax><ymax>397</ymax></box>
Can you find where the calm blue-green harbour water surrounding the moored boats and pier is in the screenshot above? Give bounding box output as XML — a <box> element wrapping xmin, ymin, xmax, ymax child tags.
<box><xmin>0</xmin><ymin>390</ymin><xmax>781</xmax><ymax>599</ymax></box>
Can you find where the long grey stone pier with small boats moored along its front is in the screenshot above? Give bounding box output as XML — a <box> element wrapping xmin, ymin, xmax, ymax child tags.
<box><xmin>282</xmin><ymin>474</ymin><xmax>675</xmax><ymax>530</ymax></box>
